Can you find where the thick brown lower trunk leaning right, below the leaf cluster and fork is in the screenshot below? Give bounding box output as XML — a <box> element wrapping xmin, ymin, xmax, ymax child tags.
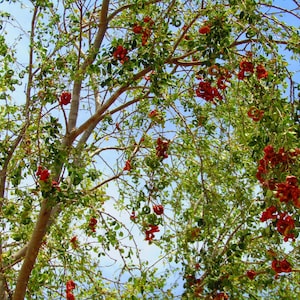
<box><xmin>13</xmin><ymin>200</ymin><xmax>52</xmax><ymax>300</ymax></box>
